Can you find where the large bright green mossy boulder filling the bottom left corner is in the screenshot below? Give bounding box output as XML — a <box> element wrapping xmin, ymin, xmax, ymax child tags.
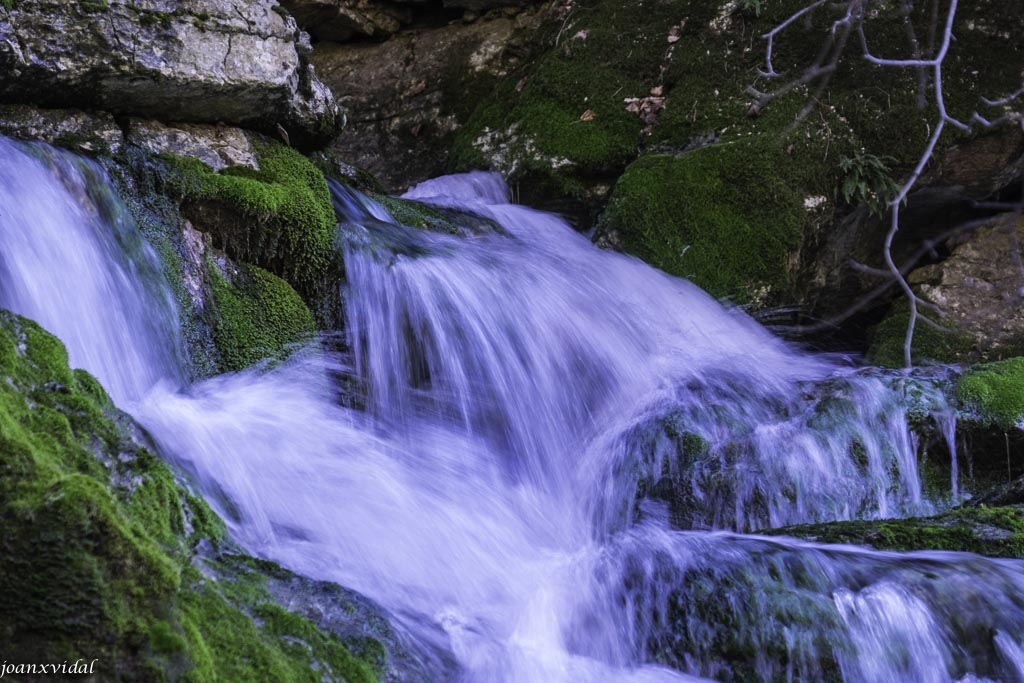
<box><xmin>0</xmin><ymin>310</ymin><xmax>381</xmax><ymax>683</ymax></box>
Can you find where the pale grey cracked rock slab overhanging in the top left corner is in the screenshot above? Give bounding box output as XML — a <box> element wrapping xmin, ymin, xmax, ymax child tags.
<box><xmin>0</xmin><ymin>0</ymin><xmax>338</xmax><ymax>146</ymax></box>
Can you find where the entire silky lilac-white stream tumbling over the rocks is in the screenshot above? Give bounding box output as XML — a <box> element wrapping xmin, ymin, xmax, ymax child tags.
<box><xmin>0</xmin><ymin>138</ymin><xmax>1024</xmax><ymax>682</ymax></box>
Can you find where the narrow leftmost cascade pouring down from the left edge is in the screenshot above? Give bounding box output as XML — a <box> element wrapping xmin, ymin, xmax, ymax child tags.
<box><xmin>0</xmin><ymin>137</ymin><xmax>183</xmax><ymax>408</ymax></box>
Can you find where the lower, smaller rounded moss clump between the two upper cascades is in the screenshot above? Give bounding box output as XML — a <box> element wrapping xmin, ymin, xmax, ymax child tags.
<box><xmin>208</xmin><ymin>264</ymin><xmax>316</xmax><ymax>372</ymax></box>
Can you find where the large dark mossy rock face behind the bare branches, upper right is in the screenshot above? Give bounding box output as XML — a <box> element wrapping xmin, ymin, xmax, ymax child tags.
<box><xmin>454</xmin><ymin>0</ymin><xmax>1024</xmax><ymax>305</ymax></box>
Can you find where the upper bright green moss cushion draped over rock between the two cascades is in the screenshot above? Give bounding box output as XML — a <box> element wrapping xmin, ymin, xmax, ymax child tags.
<box><xmin>165</xmin><ymin>142</ymin><xmax>337</xmax><ymax>303</ymax></box>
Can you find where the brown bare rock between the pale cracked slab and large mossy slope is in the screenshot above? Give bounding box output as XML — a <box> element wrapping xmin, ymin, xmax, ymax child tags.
<box><xmin>312</xmin><ymin>11</ymin><xmax>538</xmax><ymax>189</ymax></box>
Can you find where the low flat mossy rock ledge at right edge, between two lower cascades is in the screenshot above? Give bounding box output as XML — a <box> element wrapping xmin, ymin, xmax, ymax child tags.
<box><xmin>765</xmin><ymin>507</ymin><xmax>1024</xmax><ymax>558</ymax></box>
